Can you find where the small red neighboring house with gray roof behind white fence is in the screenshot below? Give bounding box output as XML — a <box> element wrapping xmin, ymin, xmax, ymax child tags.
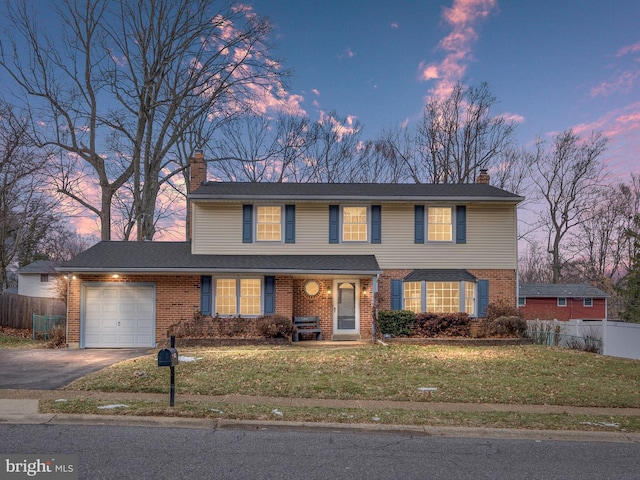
<box><xmin>518</xmin><ymin>283</ymin><xmax>609</xmax><ymax>320</ymax></box>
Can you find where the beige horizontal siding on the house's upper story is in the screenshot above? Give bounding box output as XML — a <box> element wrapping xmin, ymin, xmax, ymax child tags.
<box><xmin>193</xmin><ymin>203</ymin><xmax>517</xmax><ymax>269</ymax></box>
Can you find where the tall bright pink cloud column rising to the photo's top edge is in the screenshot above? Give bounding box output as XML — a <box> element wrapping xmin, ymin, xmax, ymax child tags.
<box><xmin>419</xmin><ymin>0</ymin><xmax>496</xmax><ymax>97</ymax></box>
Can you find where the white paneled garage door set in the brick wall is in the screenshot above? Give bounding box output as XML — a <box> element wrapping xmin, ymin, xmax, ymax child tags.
<box><xmin>83</xmin><ymin>284</ymin><xmax>155</xmax><ymax>348</ymax></box>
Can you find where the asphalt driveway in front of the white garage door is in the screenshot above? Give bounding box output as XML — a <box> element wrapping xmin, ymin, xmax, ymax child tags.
<box><xmin>0</xmin><ymin>348</ymin><xmax>150</xmax><ymax>390</ymax></box>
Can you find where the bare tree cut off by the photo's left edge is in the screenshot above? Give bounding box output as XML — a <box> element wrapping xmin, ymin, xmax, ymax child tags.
<box><xmin>0</xmin><ymin>102</ymin><xmax>58</xmax><ymax>290</ymax></box>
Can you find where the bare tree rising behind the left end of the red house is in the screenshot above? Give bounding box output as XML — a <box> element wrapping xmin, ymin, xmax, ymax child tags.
<box><xmin>529</xmin><ymin>130</ymin><xmax>606</xmax><ymax>283</ymax></box>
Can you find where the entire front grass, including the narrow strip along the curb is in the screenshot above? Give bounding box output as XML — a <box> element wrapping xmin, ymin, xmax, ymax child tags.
<box><xmin>40</xmin><ymin>345</ymin><xmax>640</xmax><ymax>432</ymax></box>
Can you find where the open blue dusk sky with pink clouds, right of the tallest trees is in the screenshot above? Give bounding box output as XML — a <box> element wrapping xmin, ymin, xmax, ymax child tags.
<box><xmin>247</xmin><ymin>0</ymin><xmax>640</xmax><ymax>179</ymax></box>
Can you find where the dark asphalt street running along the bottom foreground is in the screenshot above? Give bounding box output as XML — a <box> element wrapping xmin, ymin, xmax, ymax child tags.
<box><xmin>0</xmin><ymin>425</ymin><xmax>640</xmax><ymax>480</ymax></box>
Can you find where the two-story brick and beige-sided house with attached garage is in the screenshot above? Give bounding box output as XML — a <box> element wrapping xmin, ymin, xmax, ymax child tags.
<box><xmin>60</xmin><ymin>156</ymin><xmax>522</xmax><ymax>347</ymax></box>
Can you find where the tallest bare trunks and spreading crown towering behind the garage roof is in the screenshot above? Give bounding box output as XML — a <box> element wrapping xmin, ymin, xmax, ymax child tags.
<box><xmin>0</xmin><ymin>0</ymin><xmax>283</xmax><ymax>240</ymax></box>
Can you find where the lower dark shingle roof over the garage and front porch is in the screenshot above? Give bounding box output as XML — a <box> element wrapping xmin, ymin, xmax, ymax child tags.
<box><xmin>58</xmin><ymin>242</ymin><xmax>382</xmax><ymax>275</ymax></box>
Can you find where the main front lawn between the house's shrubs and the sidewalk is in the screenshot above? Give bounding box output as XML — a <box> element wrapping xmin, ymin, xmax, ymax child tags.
<box><xmin>67</xmin><ymin>345</ymin><xmax>640</xmax><ymax>408</ymax></box>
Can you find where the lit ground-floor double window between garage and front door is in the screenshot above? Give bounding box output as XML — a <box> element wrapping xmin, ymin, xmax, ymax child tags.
<box><xmin>214</xmin><ymin>278</ymin><xmax>262</xmax><ymax>316</ymax></box>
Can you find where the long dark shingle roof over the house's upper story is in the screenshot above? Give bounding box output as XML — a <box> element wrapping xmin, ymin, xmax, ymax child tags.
<box><xmin>189</xmin><ymin>182</ymin><xmax>524</xmax><ymax>203</ymax></box>
